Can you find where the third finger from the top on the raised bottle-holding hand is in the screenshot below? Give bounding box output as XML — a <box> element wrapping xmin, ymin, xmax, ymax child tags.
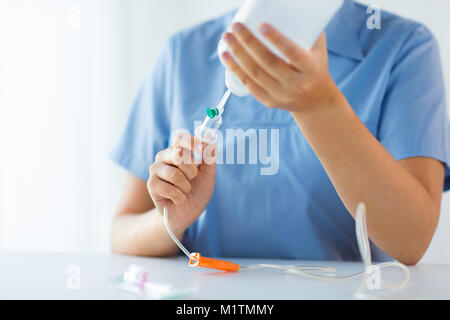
<box><xmin>224</xmin><ymin>32</ymin><xmax>280</xmax><ymax>89</ymax></box>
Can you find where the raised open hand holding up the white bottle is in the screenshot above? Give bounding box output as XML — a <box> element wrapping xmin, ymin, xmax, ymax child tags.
<box><xmin>222</xmin><ymin>23</ymin><xmax>340</xmax><ymax>112</ymax></box>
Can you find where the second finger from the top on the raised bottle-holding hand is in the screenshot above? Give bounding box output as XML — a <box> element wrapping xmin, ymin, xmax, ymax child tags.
<box><xmin>232</xmin><ymin>23</ymin><xmax>292</xmax><ymax>79</ymax></box>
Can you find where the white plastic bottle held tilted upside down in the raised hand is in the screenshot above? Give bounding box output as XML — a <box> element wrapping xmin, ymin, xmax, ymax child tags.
<box><xmin>218</xmin><ymin>0</ymin><xmax>344</xmax><ymax>97</ymax></box>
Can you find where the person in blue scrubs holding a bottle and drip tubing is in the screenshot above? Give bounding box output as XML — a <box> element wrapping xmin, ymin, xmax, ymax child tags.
<box><xmin>112</xmin><ymin>0</ymin><xmax>450</xmax><ymax>265</ymax></box>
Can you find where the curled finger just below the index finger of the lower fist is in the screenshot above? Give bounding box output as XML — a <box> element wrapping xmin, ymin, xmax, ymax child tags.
<box><xmin>155</xmin><ymin>147</ymin><xmax>198</xmax><ymax>180</ymax></box>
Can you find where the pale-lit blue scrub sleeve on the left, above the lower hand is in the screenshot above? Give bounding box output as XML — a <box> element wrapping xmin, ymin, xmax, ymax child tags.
<box><xmin>111</xmin><ymin>40</ymin><xmax>173</xmax><ymax>181</ymax></box>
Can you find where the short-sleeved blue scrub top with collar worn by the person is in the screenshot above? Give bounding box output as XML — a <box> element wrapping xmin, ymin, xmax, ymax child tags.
<box><xmin>113</xmin><ymin>0</ymin><xmax>450</xmax><ymax>261</ymax></box>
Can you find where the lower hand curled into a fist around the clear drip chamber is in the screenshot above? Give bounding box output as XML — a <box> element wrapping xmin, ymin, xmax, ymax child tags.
<box><xmin>147</xmin><ymin>134</ymin><xmax>217</xmax><ymax>234</ymax></box>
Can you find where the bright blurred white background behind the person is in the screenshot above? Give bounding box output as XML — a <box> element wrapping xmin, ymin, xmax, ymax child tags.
<box><xmin>0</xmin><ymin>0</ymin><xmax>450</xmax><ymax>263</ymax></box>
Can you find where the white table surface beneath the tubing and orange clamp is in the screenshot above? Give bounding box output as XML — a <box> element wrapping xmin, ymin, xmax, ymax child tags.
<box><xmin>0</xmin><ymin>252</ymin><xmax>450</xmax><ymax>300</ymax></box>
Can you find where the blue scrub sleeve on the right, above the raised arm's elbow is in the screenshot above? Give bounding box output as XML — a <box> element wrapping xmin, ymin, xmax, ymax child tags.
<box><xmin>378</xmin><ymin>26</ymin><xmax>450</xmax><ymax>191</ymax></box>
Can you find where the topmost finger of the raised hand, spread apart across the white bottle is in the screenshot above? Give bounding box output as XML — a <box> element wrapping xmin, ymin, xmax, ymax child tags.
<box><xmin>260</xmin><ymin>23</ymin><xmax>311</xmax><ymax>70</ymax></box>
